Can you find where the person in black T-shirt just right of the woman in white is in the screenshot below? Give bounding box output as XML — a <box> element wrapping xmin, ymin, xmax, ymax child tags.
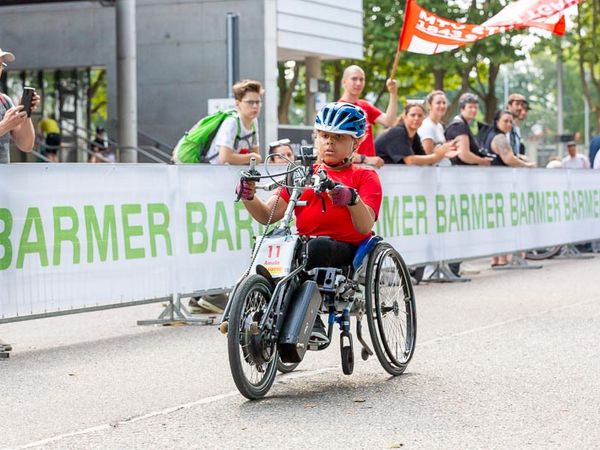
<box><xmin>445</xmin><ymin>93</ymin><xmax>493</xmax><ymax>166</ymax></box>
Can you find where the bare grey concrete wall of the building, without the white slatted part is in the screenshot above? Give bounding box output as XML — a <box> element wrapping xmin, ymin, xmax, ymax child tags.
<box><xmin>0</xmin><ymin>0</ymin><xmax>268</xmax><ymax>148</ymax></box>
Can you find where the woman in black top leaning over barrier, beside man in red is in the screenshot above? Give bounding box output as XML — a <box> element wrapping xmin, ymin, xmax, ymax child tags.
<box><xmin>375</xmin><ymin>103</ymin><xmax>456</xmax><ymax>166</ymax></box>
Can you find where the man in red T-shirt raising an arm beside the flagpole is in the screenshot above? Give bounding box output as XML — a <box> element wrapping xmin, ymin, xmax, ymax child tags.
<box><xmin>339</xmin><ymin>65</ymin><xmax>398</xmax><ymax>167</ymax></box>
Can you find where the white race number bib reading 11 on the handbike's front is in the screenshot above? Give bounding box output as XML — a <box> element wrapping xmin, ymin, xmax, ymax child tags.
<box><xmin>251</xmin><ymin>235</ymin><xmax>298</xmax><ymax>277</ymax></box>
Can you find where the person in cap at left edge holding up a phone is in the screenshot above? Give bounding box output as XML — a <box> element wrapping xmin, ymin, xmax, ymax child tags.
<box><xmin>0</xmin><ymin>48</ymin><xmax>40</xmax><ymax>164</ymax></box>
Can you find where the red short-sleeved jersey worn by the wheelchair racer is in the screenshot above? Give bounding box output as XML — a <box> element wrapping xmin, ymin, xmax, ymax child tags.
<box><xmin>281</xmin><ymin>164</ymin><xmax>383</xmax><ymax>245</ymax></box>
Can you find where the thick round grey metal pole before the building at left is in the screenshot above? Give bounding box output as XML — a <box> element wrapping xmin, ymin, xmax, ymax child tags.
<box><xmin>116</xmin><ymin>0</ymin><xmax>137</xmax><ymax>163</ymax></box>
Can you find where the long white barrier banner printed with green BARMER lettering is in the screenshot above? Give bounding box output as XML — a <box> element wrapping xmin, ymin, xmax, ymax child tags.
<box><xmin>0</xmin><ymin>164</ymin><xmax>600</xmax><ymax>319</ymax></box>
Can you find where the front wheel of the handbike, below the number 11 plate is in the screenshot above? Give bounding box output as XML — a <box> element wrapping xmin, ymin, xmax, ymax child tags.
<box><xmin>227</xmin><ymin>275</ymin><xmax>279</xmax><ymax>400</ymax></box>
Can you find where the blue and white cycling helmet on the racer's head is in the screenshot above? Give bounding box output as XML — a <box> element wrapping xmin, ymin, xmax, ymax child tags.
<box><xmin>315</xmin><ymin>102</ymin><xmax>367</xmax><ymax>138</ymax></box>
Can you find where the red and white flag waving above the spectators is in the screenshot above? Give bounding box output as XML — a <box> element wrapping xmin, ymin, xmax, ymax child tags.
<box><xmin>399</xmin><ymin>0</ymin><xmax>582</xmax><ymax>55</ymax></box>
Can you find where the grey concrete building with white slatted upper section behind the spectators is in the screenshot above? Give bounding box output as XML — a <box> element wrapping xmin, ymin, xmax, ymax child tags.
<box><xmin>0</xmin><ymin>0</ymin><xmax>363</xmax><ymax>161</ymax></box>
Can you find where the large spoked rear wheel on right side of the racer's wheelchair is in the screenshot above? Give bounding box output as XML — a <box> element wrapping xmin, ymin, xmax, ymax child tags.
<box><xmin>365</xmin><ymin>242</ymin><xmax>417</xmax><ymax>376</ymax></box>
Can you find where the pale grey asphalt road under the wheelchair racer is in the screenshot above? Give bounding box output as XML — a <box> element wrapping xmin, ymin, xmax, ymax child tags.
<box><xmin>0</xmin><ymin>258</ymin><xmax>600</xmax><ymax>450</ymax></box>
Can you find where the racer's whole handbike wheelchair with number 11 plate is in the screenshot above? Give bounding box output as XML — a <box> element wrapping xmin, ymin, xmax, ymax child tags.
<box><xmin>219</xmin><ymin>147</ymin><xmax>417</xmax><ymax>400</ymax></box>
